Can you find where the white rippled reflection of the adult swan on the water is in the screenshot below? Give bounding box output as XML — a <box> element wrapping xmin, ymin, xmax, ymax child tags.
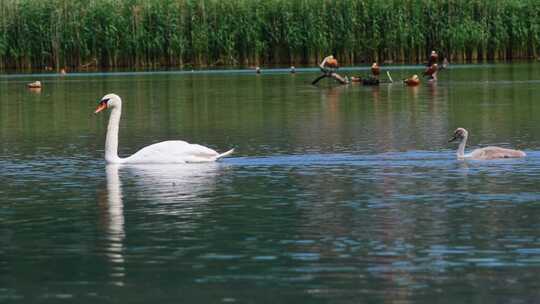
<box><xmin>100</xmin><ymin>163</ymin><xmax>224</xmax><ymax>286</ymax></box>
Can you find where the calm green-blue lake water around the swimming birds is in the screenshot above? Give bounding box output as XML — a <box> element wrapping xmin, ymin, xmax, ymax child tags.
<box><xmin>0</xmin><ymin>63</ymin><xmax>540</xmax><ymax>303</ymax></box>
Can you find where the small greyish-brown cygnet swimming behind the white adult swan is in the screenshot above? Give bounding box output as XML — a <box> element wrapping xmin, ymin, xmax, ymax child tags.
<box><xmin>448</xmin><ymin>128</ymin><xmax>527</xmax><ymax>160</ymax></box>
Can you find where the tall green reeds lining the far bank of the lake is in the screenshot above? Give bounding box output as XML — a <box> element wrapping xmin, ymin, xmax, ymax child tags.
<box><xmin>0</xmin><ymin>0</ymin><xmax>540</xmax><ymax>68</ymax></box>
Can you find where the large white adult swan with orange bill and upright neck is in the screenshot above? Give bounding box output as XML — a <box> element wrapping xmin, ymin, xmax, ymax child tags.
<box><xmin>94</xmin><ymin>94</ymin><xmax>234</xmax><ymax>164</ymax></box>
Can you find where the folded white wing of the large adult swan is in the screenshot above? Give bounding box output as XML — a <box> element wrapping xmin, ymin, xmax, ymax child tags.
<box><xmin>126</xmin><ymin>140</ymin><xmax>219</xmax><ymax>163</ymax></box>
